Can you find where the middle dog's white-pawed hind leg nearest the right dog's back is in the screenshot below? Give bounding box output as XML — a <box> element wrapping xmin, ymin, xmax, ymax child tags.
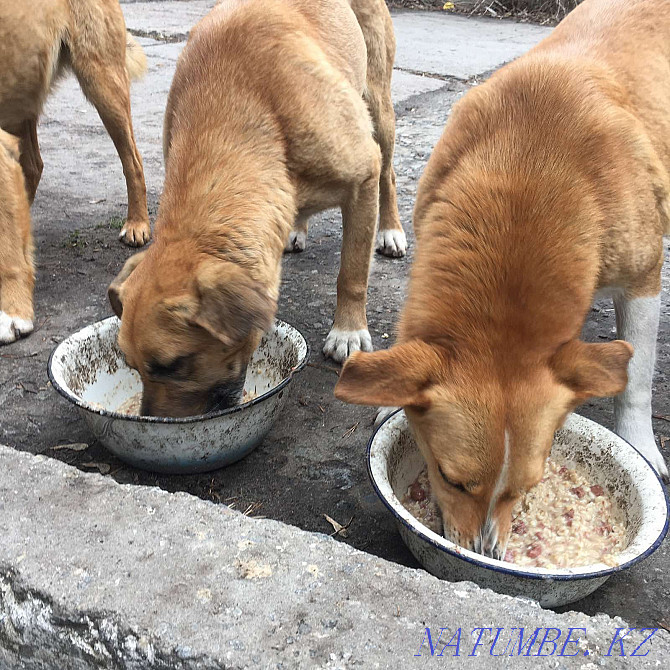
<box><xmin>352</xmin><ymin>0</ymin><xmax>407</xmax><ymax>258</ymax></box>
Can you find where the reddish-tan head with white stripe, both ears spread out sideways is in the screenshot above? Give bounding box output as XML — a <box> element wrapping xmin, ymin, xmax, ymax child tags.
<box><xmin>335</xmin><ymin>340</ymin><xmax>632</xmax><ymax>558</ymax></box>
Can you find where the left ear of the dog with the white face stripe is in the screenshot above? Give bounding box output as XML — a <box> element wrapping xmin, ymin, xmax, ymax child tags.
<box><xmin>335</xmin><ymin>340</ymin><xmax>444</xmax><ymax>408</ymax></box>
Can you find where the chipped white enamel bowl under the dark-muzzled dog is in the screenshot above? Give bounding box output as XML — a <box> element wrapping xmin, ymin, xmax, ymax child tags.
<box><xmin>49</xmin><ymin>317</ymin><xmax>308</xmax><ymax>473</ymax></box>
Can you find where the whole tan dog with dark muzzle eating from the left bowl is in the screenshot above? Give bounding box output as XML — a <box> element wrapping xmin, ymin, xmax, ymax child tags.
<box><xmin>109</xmin><ymin>0</ymin><xmax>405</xmax><ymax>416</ymax></box>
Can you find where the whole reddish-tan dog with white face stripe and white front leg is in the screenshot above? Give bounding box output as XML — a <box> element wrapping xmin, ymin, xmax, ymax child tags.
<box><xmin>335</xmin><ymin>0</ymin><xmax>670</xmax><ymax>558</ymax></box>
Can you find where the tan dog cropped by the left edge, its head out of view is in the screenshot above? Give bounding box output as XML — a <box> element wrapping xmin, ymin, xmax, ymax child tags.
<box><xmin>0</xmin><ymin>0</ymin><xmax>151</xmax><ymax>344</ymax></box>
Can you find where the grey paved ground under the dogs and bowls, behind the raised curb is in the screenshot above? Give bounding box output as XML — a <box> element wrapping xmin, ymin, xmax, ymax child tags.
<box><xmin>0</xmin><ymin>0</ymin><xmax>670</xmax><ymax>644</ymax></box>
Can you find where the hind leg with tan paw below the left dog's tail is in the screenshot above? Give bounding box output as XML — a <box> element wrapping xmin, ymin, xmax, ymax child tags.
<box><xmin>68</xmin><ymin>5</ymin><xmax>151</xmax><ymax>247</ymax></box>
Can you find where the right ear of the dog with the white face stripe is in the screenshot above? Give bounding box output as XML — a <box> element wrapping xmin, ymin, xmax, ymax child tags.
<box><xmin>551</xmin><ymin>340</ymin><xmax>633</xmax><ymax>400</ymax></box>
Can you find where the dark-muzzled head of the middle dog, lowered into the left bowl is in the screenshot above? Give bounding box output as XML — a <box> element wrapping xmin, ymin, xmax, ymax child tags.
<box><xmin>108</xmin><ymin>243</ymin><xmax>276</xmax><ymax>417</ymax></box>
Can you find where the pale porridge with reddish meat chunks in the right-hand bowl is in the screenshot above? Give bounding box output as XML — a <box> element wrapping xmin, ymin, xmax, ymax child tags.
<box><xmin>401</xmin><ymin>458</ymin><xmax>626</xmax><ymax>569</ymax></box>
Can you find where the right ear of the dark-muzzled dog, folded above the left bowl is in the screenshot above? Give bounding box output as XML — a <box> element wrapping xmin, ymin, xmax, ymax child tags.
<box><xmin>192</xmin><ymin>260</ymin><xmax>277</xmax><ymax>345</ymax></box>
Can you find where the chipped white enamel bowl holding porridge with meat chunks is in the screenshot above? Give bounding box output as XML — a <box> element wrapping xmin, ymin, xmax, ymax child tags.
<box><xmin>368</xmin><ymin>411</ymin><xmax>669</xmax><ymax>607</ymax></box>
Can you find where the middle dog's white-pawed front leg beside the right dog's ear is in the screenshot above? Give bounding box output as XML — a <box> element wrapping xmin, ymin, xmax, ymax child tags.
<box><xmin>323</xmin><ymin>153</ymin><xmax>380</xmax><ymax>362</ymax></box>
